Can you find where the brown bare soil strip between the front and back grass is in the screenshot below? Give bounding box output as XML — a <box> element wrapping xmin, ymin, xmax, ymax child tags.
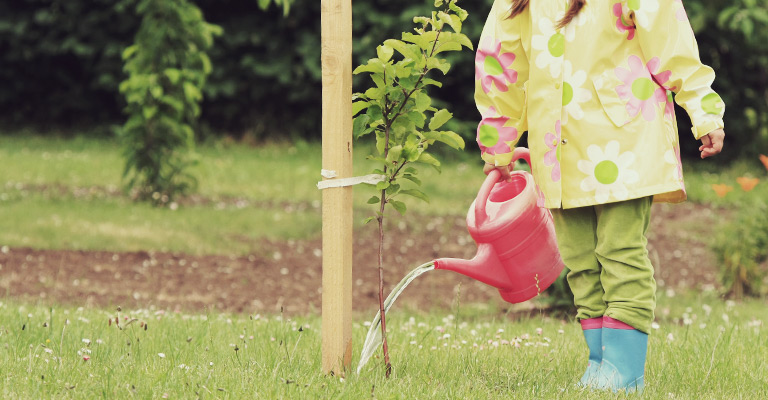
<box><xmin>0</xmin><ymin>203</ymin><xmax>720</xmax><ymax>314</ymax></box>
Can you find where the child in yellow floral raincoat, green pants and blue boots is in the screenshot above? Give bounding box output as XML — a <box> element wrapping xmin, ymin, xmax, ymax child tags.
<box><xmin>475</xmin><ymin>0</ymin><xmax>725</xmax><ymax>392</ymax></box>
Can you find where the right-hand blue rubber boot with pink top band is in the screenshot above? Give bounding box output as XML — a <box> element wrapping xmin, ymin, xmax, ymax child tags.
<box><xmin>596</xmin><ymin>317</ymin><xmax>648</xmax><ymax>393</ymax></box>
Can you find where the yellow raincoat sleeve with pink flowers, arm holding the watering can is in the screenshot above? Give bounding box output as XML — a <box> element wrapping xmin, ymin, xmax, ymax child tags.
<box><xmin>475</xmin><ymin>0</ymin><xmax>528</xmax><ymax>166</ymax></box>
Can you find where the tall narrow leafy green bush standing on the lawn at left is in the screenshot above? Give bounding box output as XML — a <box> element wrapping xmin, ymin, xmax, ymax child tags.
<box><xmin>120</xmin><ymin>0</ymin><xmax>221</xmax><ymax>203</ymax></box>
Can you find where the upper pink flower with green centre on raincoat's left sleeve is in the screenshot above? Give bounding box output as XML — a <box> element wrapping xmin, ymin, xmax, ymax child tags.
<box><xmin>475</xmin><ymin>42</ymin><xmax>517</xmax><ymax>93</ymax></box>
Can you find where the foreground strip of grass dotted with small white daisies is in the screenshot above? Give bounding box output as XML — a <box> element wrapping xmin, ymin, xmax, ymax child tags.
<box><xmin>0</xmin><ymin>293</ymin><xmax>768</xmax><ymax>400</ymax></box>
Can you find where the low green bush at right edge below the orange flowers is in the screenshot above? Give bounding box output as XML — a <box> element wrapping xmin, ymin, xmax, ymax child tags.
<box><xmin>712</xmin><ymin>199</ymin><xmax>768</xmax><ymax>299</ymax></box>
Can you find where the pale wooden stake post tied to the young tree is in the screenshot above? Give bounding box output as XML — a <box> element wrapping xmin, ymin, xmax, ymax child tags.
<box><xmin>320</xmin><ymin>0</ymin><xmax>352</xmax><ymax>376</ymax></box>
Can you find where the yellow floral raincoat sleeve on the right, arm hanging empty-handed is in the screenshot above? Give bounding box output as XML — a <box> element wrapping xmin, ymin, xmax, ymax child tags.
<box><xmin>621</xmin><ymin>0</ymin><xmax>725</xmax><ymax>139</ymax></box>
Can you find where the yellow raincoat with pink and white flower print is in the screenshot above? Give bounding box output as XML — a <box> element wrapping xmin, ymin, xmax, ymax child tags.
<box><xmin>475</xmin><ymin>0</ymin><xmax>725</xmax><ymax>208</ymax></box>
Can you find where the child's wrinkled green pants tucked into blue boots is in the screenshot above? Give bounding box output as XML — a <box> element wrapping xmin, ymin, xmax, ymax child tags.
<box><xmin>552</xmin><ymin>197</ymin><xmax>656</xmax><ymax>333</ymax></box>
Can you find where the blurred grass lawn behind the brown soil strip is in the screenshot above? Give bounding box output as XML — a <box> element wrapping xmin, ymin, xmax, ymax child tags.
<box><xmin>0</xmin><ymin>135</ymin><xmax>768</xmax><ymax>255</ymax></box>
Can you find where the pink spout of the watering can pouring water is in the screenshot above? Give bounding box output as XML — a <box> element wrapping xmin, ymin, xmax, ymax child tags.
<box><xmin>434</xmin><ymin>243</ymin><xmax>510</xmax><ymax>289</ymax></box>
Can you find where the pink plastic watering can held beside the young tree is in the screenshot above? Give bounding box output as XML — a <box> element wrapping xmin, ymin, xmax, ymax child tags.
<box><xmin>434</xmin><ymin>148</ymin><xmax>564</xmax><ymax>303</ymax></box>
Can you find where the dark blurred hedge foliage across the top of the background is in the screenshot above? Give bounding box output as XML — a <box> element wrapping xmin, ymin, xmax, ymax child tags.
<box><xmin>0</xmin><ymin>0</ymin><xmax>768</xmax><ymax>158</ymax></box>
